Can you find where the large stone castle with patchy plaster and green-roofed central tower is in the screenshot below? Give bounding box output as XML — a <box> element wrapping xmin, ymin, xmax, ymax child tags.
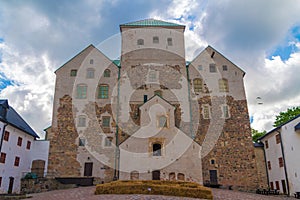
<box><xmin>47</xmin><ymin>19</ymin><xmax>260</xmax><ymax>190</ymax></box>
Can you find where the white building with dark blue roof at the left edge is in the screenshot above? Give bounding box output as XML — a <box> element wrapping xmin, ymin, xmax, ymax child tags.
<box><xmin>0</xmin><ymin>100</ymin><xmax>49</xmax><ymax>193</ymax></box>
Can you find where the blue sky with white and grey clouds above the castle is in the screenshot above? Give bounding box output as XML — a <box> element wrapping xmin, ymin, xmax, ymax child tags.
<box><xmin>0</xmin><ymin>0</ymin><xmax>300</xmax><ymax>137</ymax></box>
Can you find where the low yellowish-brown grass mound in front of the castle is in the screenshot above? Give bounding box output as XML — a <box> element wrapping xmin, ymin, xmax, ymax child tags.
<box><xmin>95</xmin><ymin>181</ymin><xmax>213</xmax><ymax>199</ymax></box>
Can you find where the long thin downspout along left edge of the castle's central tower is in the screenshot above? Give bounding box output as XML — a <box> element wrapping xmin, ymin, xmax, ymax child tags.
<box><xmin>113</xmin><ymin>66</ymin><xmax>121</xmax><ymax>181</ymax></box>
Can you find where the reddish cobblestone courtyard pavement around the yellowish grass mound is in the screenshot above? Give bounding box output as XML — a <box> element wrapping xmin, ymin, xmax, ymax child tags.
<box><xmin>28</xmin><ymin>186</ymin><xmax>295</xmax><ymax>200</ymax></box>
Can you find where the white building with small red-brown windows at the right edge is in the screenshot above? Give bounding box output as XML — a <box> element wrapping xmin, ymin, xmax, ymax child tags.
<box><xmin>260</xmin><ymin>115</ymin><xmax>300</xmax><ymax>195</ymax></box>
